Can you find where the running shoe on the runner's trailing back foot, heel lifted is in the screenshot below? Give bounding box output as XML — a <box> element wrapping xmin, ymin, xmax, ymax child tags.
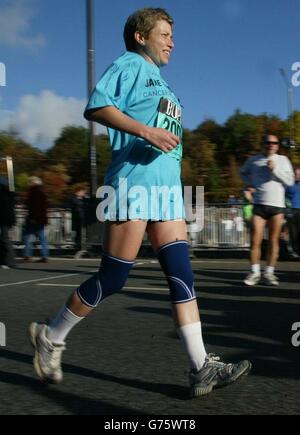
<box><xmin>29</xmin><ymin>323</ymin><xmax>66</xmax><ymax>384</ymax></box>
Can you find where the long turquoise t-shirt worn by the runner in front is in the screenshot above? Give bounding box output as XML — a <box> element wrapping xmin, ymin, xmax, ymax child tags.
<box><xmin>85</xmin><ymin>52</ymin><xmax>185</xmax><ymax>221</ymax></box>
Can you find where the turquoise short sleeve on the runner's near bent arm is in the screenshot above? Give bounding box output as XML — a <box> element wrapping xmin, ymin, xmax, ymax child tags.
<box><xmin>85</xmin><ymin>64</ymin><xmax>135</xmax><ymax>115</ymax></box>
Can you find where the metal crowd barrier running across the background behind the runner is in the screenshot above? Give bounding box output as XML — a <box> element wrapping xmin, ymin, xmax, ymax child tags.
<box><xmin>11</xmin><ymin>205</ymin><xmax>250</xmax><ymax>249</ymax></box>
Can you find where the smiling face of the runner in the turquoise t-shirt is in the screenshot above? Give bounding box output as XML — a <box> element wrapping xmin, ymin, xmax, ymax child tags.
<box><xmin>136</xmin><ymin>20</ymin><xmax>174</xmax><ymax>67</ymax></box>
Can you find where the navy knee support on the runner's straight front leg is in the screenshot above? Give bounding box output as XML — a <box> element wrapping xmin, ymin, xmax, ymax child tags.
<box><xmin>158</xmin><ymin>241</ymin><xmax>196</xmax><ymax>304</ymax></box>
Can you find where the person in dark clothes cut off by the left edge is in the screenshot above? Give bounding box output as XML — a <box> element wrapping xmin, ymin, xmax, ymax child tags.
<box><xmin>0</xmin><ymin>177</ymin><xmax>16</xmax><ymax>269</ymax></box>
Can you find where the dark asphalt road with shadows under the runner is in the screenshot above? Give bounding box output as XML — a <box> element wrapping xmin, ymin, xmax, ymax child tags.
<box><xmin>0</xmin><ymin>259</ymin><xmax>300</xmax><ymax>416</ymax></box>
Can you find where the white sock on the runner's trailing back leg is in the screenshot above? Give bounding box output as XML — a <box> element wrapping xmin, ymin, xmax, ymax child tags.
<box><xmin>47</xmin><ymin>306</ymin><xmax>84</xmax><ymax>344</ymax></box>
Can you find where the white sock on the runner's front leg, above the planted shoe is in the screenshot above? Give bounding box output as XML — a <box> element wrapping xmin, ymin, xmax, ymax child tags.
<box><xmin>177</xmin><ymin>322</ymin><xmax>207</xmax><ymax>371</ymax></box>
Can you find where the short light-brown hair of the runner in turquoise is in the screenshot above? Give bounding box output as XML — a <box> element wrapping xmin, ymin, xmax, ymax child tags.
<box><xmin>124</xmin><ymin>8</ymin><xmax>174</xmax><ymax>51</ymax></box>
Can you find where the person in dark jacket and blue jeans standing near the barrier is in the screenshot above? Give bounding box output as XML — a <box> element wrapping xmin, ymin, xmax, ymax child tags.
<box><xmin>24</xmin><ymin>177</ymin><xmax>49</xmax><ymax>263</ymax></box>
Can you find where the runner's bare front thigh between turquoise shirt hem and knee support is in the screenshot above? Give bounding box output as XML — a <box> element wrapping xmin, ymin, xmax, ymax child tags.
<box><xmin>147</xmin><ymin>220</ymin><xmax>188</xmax><ymax>251</ymax></box>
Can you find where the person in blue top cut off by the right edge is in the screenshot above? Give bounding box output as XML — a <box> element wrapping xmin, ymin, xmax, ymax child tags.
<box><xmin>286</xmin><ymin>168</ymin><xmax>300</xmax><ymax>256</ymax></box>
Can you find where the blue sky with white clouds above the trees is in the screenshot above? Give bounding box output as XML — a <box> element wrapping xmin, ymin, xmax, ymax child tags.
<box><xmin>0</xmin><ymin>0</ymin><xmax>300</xmax><ymax>149</ymax></box>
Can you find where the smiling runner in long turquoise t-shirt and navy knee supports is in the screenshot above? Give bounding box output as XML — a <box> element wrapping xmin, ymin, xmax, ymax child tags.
<box><xmin>30</xmin><ymin>8</ymin><xmax>252</xmax><ymax>397</ymax></box>
